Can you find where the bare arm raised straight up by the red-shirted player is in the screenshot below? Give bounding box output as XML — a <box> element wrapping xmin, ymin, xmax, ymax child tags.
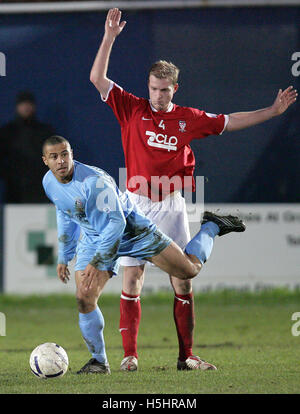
<box><xmin>90</xmin><ymin>8</ymin><xmax>126</xmax><ymax>97</ymax></box>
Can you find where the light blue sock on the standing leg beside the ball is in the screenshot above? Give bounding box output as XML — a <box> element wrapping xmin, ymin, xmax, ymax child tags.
<box><xmin>79</xmin><ymin>306</ymin><xmax>107</xmax><ymax>363</ymax></box>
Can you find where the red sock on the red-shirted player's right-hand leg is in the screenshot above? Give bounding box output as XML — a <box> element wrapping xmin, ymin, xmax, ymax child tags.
<box><xmin>174</xmin><ymin>292</ymin><xmax>195</xmax><ymax>361</ymax></box>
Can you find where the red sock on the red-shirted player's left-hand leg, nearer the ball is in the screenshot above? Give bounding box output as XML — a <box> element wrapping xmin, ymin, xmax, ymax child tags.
<box><xmin>120</xmin><ymin>291</ymin><xmax>141</xmax><ymax>358</ymax></box>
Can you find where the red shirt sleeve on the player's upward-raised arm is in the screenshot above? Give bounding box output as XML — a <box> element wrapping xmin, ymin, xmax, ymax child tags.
<box><xmin>102</xmin><ymin>82</ymin><xmax>142</xmax><ymax>124</ymax></box>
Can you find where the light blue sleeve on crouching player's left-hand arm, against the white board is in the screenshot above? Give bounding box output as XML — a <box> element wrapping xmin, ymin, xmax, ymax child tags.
<box><xmin>56</xmin><ymin>207</ymin><xmax>80</xmax><ymax>264</ymax></box>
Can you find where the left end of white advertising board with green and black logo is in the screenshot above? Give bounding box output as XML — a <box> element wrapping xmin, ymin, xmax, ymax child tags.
<box><xmin>4</xmin><ymin>204</ymin><xmax>75</xmax><ymax>294</ymax></box>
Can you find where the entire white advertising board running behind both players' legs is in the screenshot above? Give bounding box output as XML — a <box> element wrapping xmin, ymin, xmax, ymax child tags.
<box><xmin>4</xmin><ymin>204</ymin><xmax>300</xmax><ymax>294</ymax></box>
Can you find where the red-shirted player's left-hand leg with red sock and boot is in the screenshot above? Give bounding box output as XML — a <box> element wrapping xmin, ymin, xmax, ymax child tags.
<box><xmin>119</xmin><ymin>257</ymin><xmax>145</xmax><ymax>371</ymax></box>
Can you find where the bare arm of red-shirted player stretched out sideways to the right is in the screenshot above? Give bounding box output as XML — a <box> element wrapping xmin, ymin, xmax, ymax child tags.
<box><xmin>226</xmin><ymin>86</ymin><xmax>298</xmax><ymax>131</ymax></box>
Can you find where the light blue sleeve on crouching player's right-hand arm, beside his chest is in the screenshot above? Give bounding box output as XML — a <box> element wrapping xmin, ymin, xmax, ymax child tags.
<box><xmin>85</xmin><ymin>176</ymin><xmax>126</xmax><ymax>270</ymax></box>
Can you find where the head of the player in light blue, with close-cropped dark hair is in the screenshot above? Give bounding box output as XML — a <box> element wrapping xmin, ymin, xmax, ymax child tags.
<box><xmin>43</xmin><ymin>142</ymin><xmax>74</xmax><ymax>183</ymax></box>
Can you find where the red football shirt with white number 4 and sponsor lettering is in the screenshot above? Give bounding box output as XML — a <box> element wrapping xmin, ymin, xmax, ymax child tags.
<box><xmin>102</xmin><ymin>83</ymin><xmax>227</xmax><ymax>201</ymax></box>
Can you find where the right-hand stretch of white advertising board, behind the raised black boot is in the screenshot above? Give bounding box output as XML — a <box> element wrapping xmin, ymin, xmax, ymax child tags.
<box><xmin>144</xmin><ymin>204</ymin><xmax>300</xmax><ymax>291</ymax></box>
